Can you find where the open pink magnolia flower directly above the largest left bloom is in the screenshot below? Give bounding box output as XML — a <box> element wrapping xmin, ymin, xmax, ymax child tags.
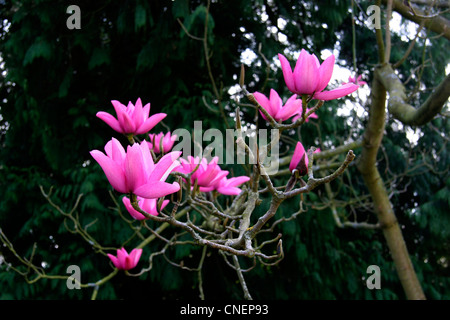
<box><xmin>97</xmin><ymin>98</ymin><xmax>167</xmax><ymax>135</ymax></box>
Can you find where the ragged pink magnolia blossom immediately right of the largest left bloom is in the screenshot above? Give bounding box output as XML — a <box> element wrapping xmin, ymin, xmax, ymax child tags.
<box><xmin>175</xmin><ymin>156</ymin><xmax>250</xmax><ymax>195</ymax></box>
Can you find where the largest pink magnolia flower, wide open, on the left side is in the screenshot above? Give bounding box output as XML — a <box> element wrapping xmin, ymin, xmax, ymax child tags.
<box><xmin>90</xmin><ymin>138</ymin><xmax>181</xmax><ymax>199</ymax></box>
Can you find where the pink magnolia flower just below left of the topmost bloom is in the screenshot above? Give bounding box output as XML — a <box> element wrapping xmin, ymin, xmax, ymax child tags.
<box><xmin>253</xmin><ymin>89</ymin><xmax>302</xmax><ymax>121</ymax></box>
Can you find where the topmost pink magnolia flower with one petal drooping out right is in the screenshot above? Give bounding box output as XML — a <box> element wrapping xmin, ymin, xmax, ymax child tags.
<box><xmin>278</xmin><ymin>49</ymin><xmax>359</xmax><ymax>100</ymax></box>
